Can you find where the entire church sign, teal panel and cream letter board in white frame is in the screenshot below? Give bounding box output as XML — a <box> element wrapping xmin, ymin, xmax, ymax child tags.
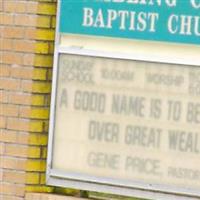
<box><xmin>47</xmin><ymin>0</ymin><xmax>200</xmax><ymax>200</ymax></box>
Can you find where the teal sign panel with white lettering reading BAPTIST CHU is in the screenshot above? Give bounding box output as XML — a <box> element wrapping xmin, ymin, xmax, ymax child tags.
<box><xmin>60</xmin><ymin>0</ymin><xmax>200</xmax><ymax>45</ymax></box>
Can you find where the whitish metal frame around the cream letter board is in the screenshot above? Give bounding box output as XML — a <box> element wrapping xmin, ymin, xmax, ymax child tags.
<box><xmin>46</xmin><ymin>0</ymin><xmax>200</xmax><ymax>200</ymax></box>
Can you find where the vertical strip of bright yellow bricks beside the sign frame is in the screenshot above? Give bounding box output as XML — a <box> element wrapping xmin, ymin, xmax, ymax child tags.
<box><xmin>24</xmin><ymin>0</ymin><xmax>56</xmax><ymax>195</ymax></box>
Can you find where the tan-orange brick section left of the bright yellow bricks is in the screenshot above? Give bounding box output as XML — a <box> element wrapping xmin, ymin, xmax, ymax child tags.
<box><xmin>0</xmin><ymin>0</ymin><xmax>38</xmax><ymax>200</ymax></box>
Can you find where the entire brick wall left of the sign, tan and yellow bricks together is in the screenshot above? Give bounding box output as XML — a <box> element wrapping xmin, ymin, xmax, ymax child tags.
<box><xmin>0</xmin><ymin>0</ymin><xmax>59</xmax><ymax>200</ymax></box>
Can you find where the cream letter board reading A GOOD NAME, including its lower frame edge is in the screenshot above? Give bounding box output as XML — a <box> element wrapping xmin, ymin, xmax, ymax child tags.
<box><xmin>48</xmin><ymin>54</ymin><xmax>200</xmax><ymax>199</ymax></box>
